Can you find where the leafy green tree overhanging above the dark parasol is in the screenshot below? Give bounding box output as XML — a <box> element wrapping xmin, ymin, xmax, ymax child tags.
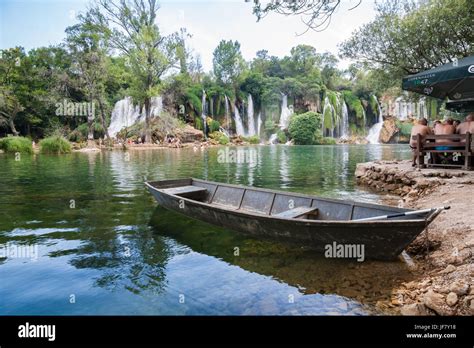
<box><xmin>340</xmin><ymin>0</ymin><xmax>474</xmax><ymax>82</ymax></box>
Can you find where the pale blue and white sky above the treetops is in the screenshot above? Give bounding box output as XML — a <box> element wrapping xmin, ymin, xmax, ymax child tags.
<box><xmin>0</xmin><ymin>0</ymin><xmax>375</xmax><ymax>71</ymax></box>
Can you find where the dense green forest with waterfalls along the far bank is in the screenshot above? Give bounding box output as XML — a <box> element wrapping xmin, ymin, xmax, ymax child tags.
<box><xmin>0</xmin><ymin>0</ymin><xmax>474</xmax><ymax>143</ymax></box>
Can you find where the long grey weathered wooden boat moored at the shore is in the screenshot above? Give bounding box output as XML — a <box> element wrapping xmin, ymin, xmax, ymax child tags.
<box><xmin>145</xmin><ymin>178</ymin><xmax>441</xmax><ymax>260</ymax></box>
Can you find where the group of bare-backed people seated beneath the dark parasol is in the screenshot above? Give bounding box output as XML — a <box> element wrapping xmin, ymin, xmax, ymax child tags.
<box><xmin>410</xmin><ymin>113</ymin><xmax>474</xmax><ymax>166</ymax></box>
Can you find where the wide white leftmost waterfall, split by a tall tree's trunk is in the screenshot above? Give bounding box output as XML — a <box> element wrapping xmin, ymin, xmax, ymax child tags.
<box><xmin>108</xmin><ymin>96</ymin><xmax>163</xmax><ymax>138</ymax></box>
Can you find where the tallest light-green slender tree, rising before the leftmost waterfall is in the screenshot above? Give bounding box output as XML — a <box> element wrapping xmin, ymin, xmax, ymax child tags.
<box><xmin>91</xmin><ymin>0</ymin><xmax>182</xmax><ymax>143</ymax></box>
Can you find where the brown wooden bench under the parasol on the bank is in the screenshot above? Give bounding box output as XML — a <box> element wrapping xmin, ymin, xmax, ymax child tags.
<box><xmin>412</xmin><ymin>133</ymin><xmax>474</xmax><ymax>170</ymax></box>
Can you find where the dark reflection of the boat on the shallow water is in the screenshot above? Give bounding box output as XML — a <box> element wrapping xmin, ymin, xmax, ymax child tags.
<box><xmin>150</xmin><ymin>207</ymin><xmax>413</xmax><ymax>305</ymax></box>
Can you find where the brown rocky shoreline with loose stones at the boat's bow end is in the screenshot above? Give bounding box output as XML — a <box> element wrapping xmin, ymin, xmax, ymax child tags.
<box><xmin>356</xmin><ymin>161</ymin><xmax>474</xmax><ymax>315</ymax></box>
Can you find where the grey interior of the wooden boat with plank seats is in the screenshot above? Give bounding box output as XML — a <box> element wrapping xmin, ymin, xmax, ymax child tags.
<box><xmin>149</xmin><ymin>178</ymin><xmax>427</xmax><ymax>221</ymax></box>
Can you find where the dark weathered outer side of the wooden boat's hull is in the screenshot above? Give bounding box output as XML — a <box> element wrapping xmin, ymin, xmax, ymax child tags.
<box><xmin>147</xmin><ymin>179</ymin><xmax>440</xmax><ymax>260</ymax></box>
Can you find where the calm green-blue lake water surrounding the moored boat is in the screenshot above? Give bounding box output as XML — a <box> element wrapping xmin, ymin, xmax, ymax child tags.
<box><xmin>0</xmin><ymin>145</ymin><xmax>412</xmax><ymax>315</ymax></box>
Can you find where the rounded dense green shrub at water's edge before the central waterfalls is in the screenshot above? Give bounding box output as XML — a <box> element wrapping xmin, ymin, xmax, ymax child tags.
<box><xmin>288</xmin><ymin>111</ymin><xmax>321</xmax><ymax>145</ymax></box>
